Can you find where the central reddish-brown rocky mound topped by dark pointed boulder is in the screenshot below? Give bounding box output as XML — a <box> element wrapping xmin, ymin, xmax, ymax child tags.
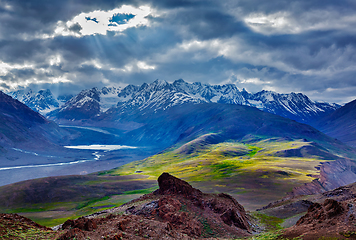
<box><xmin>58</xmin><ymin>173</ymin><xmax>251</xmax><ymax>240</ymax></box>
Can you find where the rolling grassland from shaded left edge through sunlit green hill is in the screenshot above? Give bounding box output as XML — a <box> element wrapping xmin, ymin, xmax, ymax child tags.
<box><xmin>0</xmin><ymin>131</ymin><xmax>354</xmax><ymax>226</ymax></box>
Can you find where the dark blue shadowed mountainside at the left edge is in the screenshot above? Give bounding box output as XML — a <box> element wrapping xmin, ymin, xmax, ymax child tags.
<box><xmin>0</xmin><ymin>92</ymin><xmax>62</xmax><ymax>149</ymax></box>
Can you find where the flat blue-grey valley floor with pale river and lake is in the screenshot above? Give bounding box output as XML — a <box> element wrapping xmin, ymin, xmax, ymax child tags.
<box><xmin>0</xmin><ymin>126</ymin><xmax>153</xmax><ymax>186</ymax></box>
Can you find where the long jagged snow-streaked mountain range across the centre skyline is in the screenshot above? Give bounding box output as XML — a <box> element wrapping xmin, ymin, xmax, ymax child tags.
<box><xmin>50</xmin><ymin>79</ymin><xmax>340</xmax><ymax>122</ymax></box>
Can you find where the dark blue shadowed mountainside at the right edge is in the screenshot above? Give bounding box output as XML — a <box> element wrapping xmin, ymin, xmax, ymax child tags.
<box><xmin>312</xmin><ymin>100</ymin><xmax>356</xmax><ymax>147</ymax></box>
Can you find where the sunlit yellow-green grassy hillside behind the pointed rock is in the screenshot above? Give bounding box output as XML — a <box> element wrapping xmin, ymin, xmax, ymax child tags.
<box><xmin>105</xmin><ymin>136</ymin><xmax>325</xmax><ymax>210</ymax></box>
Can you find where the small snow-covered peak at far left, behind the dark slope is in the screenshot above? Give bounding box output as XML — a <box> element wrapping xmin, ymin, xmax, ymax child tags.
<box><xmin>8</xmin><ymin>89</ymin><xmax>73</xmax><ymax>115</ymax></box>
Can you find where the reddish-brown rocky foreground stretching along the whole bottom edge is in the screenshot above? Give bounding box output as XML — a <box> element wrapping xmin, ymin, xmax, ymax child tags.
<box><xmin>0</xmin><ymin>173</ymin><xmax>356</xmax><ymax>240</ymax></box>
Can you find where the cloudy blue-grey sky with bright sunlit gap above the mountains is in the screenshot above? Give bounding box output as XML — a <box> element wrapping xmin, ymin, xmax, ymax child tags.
<box><xmin>0</xmin><ymin>0</ymin><xmax>356</xmax><ymax>104</ymax></box>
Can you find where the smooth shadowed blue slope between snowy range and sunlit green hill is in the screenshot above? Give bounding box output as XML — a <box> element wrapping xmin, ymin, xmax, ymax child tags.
<box><xmin>103</xmin><ymin>103</ymin><xmax>345</xmax><ymax>154</ymax></box>
